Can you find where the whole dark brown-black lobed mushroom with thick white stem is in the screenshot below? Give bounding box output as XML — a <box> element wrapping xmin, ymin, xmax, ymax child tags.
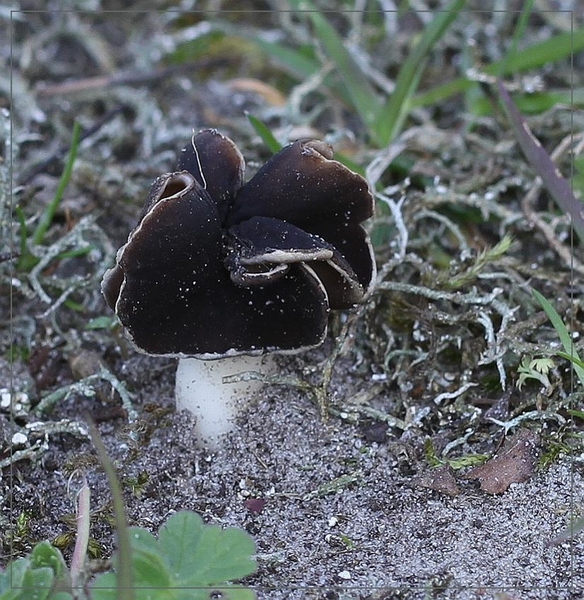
<box><xmin>102</xmin><ymin>129</ymin><xmax>375</xmax><ymax>447</ymax></box>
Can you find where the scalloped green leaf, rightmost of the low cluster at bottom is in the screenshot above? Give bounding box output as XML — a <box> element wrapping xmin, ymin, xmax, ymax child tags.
<box><xmin>158</xmin><ymin>511</ymin><xmax>256</xmax><ymax>587</ymax></box>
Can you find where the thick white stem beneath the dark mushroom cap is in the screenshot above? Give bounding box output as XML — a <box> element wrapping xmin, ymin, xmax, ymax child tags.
<box><xmin>175</xmin><ymin>355</ymin><xmax>276</xmax><ymax>450</ymax></box>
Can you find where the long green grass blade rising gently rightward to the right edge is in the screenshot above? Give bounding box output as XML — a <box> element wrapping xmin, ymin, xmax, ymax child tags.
<box><xmin>411</xmin><ymin>27</ymin><xmax>584</xmax><ymax>108</ymax></box>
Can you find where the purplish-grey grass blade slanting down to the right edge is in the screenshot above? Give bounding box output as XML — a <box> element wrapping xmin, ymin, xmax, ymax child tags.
<box><xmin>497</xmin><ymin>80</ymin><xmax>584</xmax><ymax>242</ymax></box>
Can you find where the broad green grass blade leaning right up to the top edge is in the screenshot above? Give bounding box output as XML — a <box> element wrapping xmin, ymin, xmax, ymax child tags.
<box><xmin>376</xmin><ymin>0</ymin><xmax>465</xmax><ymax>146</ymax></box>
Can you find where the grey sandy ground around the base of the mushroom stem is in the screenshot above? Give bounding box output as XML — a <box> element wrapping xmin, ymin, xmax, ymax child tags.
<box><xmin>2</xmin><ymin>350</ymin><xmax>584</xmax><ymax>600</ymax></box>
